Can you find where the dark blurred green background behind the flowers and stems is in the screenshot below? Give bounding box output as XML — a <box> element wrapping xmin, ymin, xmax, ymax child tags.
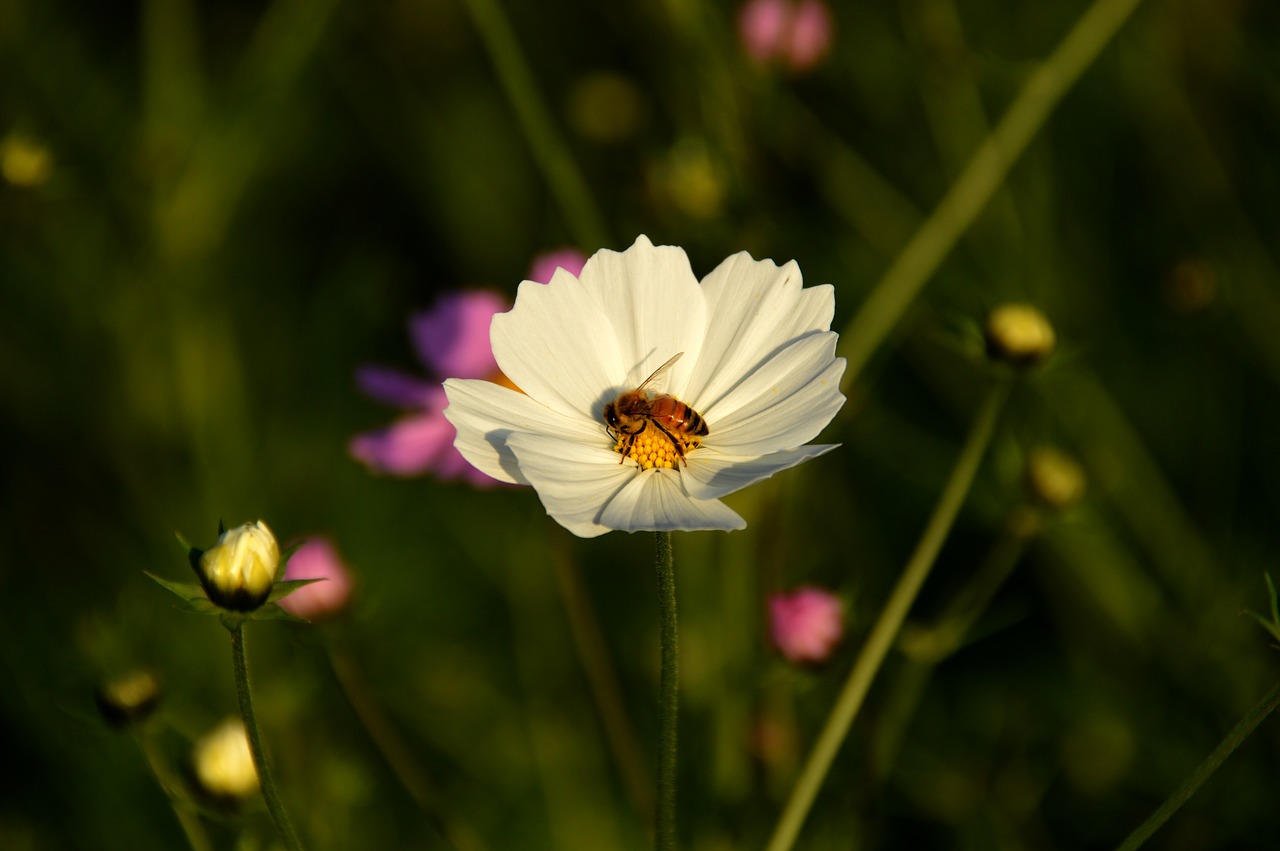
<box><xmin>0</xmin><ymin>0</ymin><xmax>1280</xmax><ymax>851</ymax></box>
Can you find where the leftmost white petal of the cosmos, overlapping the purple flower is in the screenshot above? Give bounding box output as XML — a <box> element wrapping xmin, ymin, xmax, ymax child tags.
<box><xmin>444</xmin><ymin>379</ymin><xmax>603</xmax><ymax>485</ymax></box>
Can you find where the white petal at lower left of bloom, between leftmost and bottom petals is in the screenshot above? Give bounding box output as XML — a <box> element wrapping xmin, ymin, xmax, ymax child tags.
<box><xmin>507</xmin><ymin>433</ymin><xmax>636</xmax><ymax>537</ymax></box>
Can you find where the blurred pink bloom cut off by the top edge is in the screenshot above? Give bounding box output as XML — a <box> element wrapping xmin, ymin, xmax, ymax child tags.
<box><xmin>737</xmin><ymin>0</ymin><xmax>833</xmax><ymax>72</ymax></box>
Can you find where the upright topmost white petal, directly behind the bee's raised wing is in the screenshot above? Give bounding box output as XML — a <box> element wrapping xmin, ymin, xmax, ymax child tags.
<box><xmin>581</xmin><ymin>235</ymin><xmax>707</xmax><ymax>395</ymax></box>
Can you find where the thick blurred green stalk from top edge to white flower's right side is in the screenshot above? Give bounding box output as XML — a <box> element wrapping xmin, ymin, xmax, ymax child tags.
<box><xmin>840</xmin><ymin>0</ymin><xmax>1140</xmax><ymax>394</ymax></box>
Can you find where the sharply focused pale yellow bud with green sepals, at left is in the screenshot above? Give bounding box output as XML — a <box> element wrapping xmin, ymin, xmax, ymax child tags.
<box><xmin>200</xmin><ymin>521</ymin><xmax>280</xmax><ymax>612</ymax></box>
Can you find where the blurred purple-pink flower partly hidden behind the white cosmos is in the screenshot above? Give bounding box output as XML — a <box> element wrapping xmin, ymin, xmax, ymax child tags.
<box><xmin>348</xmin><ymin>248</ymin><xmax>586</xmax><ymax>488</ymax></box>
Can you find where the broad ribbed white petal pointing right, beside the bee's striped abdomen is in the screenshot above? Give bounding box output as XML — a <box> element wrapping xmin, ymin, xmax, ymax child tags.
<box><xmin>699</xmin><ymin>331</ymin><xmax>845</xmax><ymax>457</ymax></box>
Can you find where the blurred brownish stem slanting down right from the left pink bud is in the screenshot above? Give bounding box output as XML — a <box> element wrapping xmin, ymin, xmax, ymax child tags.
<box><xmin>325</xmin><ymin>641</ymin><xmax>484</xmax><ymax>851</ymax></box>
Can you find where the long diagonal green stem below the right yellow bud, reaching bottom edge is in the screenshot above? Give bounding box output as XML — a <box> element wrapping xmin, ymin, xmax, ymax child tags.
<box><xmin>768</xmin><ymin>380</ymin><xmax>1009</xmax><ymax>851</ymax></box>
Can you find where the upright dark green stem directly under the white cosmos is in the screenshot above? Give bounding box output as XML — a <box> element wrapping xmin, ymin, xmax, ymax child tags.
<box><xmin>654</xmin><ymin>532</ymin><xmax>678</xmax><ymax>851</ymax></box>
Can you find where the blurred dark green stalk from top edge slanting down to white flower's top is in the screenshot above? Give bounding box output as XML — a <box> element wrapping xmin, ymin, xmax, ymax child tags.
<box><xmin>463</xmin><ymin>0</ymin><xmax>608</xmax><ymax>251</ymax></box>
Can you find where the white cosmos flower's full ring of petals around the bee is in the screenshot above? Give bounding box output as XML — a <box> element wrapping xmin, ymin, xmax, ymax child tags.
<box><xmin>444</xmin><ymin>237</ymin><xmax>845</xmax><ymax>537</ymax></box>
